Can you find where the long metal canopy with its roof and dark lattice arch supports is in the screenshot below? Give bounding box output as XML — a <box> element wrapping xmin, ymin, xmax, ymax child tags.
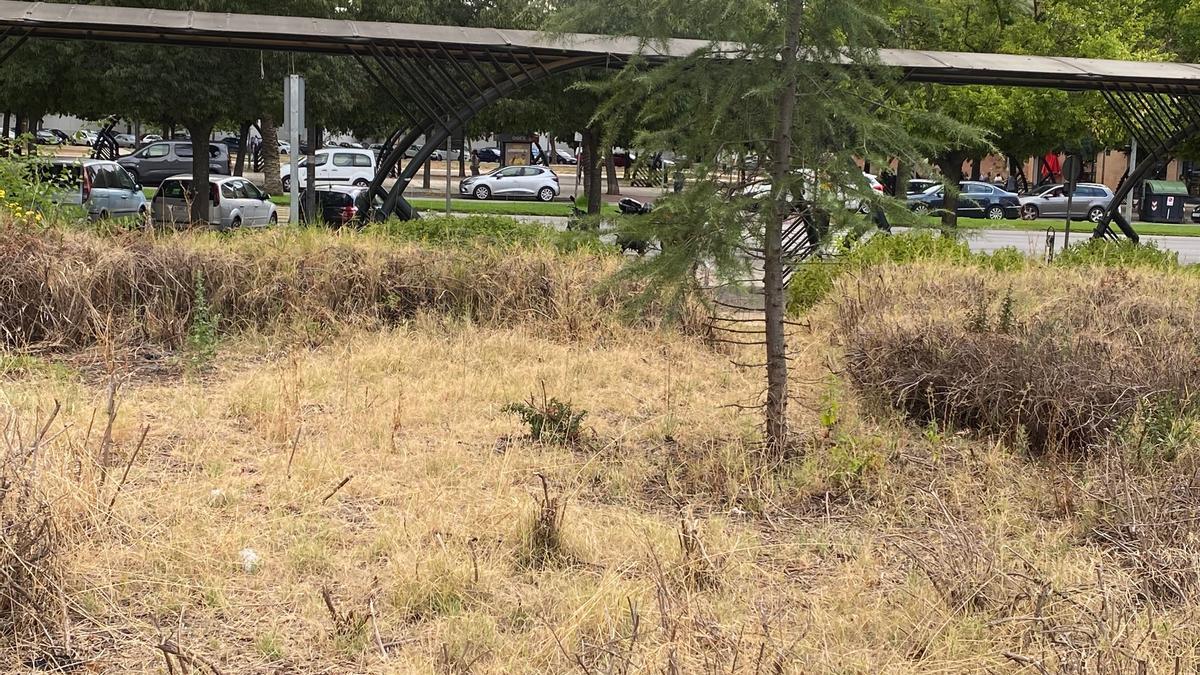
<box><xmin>0</xmin><ymin>0</ymin><xmax>1200</xmax><ymax>239</ymax></box>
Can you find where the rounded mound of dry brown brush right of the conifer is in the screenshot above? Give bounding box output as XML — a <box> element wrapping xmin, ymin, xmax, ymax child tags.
<box><xmin>838</xmin><ymin>268</ymin><xmax>1200</xmax><ymax>452</ymax></box>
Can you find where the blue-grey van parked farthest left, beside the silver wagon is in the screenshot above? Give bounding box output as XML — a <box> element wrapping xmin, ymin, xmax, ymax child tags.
<box><xmin>34</xmin><ymin>160</ymin><xmax>149</xmax><ymax>221</ymax></box>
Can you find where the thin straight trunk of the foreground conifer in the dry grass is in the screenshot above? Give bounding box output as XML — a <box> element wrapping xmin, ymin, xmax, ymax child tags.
<box><xmin>762</xmin><ymin>0</ymin><xmax>804</xmax><ymax>458</ymax></box>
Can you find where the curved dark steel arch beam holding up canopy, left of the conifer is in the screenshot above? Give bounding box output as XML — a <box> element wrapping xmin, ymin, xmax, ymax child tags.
<box><xmin>372</xmin><ymin>55</ymin><xmax>612</xmax><ymax>220</ymax></box>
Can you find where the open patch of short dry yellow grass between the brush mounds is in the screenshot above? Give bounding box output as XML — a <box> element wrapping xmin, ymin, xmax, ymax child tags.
<box><xmin>7</xmin><ymin>253</ymin><xmax>1200</xmax><ymax>674</ymax></box>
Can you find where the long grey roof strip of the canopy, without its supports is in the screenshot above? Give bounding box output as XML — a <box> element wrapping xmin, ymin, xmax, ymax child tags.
<box><xmin>7</xmin><ymin>0</ymin><xmax>1200</xmax><ymax>94</ymax></box>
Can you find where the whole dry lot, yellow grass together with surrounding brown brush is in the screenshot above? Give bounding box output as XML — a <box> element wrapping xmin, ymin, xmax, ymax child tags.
<box><xmin>7</xmin><ymin>224</ymin><xmax>1200</xmax><ymax>675</ymax></box>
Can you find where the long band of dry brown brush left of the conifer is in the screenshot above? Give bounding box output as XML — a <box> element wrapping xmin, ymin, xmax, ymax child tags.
<box><xmin>0</xmin><ymin>229</ymin><xmax>676</xmax><ymax>347</ymax></box>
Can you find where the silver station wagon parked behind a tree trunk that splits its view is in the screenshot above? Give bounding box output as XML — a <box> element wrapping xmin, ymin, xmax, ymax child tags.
<box><xmin>150</xmin><ymin>173</ymin><xmax>280</xmax><ymax>229</ymax></box>
